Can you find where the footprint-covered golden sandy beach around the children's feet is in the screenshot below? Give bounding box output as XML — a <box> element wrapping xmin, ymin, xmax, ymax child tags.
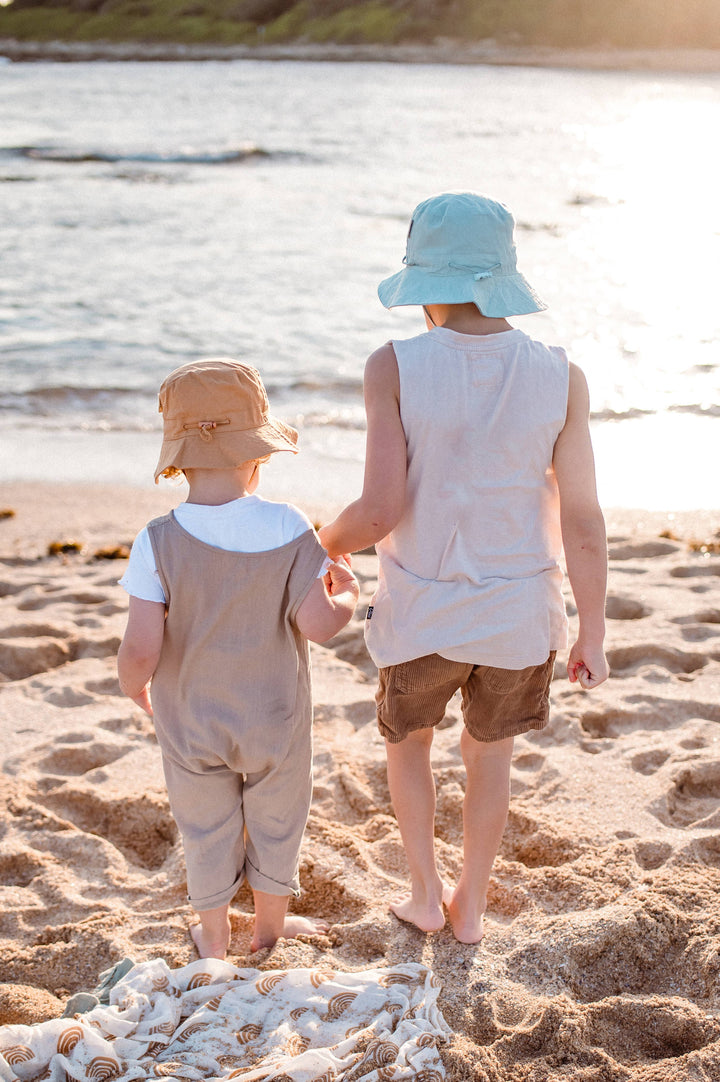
<box><xmin>0</xmin><ymin>484</ymin><xmax>720</xmax><ymax>1082</ymax></box>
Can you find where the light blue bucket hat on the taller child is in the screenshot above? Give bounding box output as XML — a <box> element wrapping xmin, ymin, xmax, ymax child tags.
<box><xmin>378</xmin><ymin>192</ymin><xmax>547</xmax><ymax>317</ymax></box>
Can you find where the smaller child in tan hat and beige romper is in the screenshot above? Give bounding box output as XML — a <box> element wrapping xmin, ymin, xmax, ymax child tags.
<box><xmin>118</xmin><ymin>359</ymin><xmax>358</xmax><ymax>958</ymax></box>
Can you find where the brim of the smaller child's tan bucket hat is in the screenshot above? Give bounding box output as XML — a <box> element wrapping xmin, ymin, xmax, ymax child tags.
<box><xmin>155</xmin><ymin>417</ymin><xmax>298</xmax><ymax>483</ymax></box>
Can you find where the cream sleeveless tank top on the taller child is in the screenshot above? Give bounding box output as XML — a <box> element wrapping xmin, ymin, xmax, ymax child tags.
<box><xmin>365</xmin><ymin>327</ymin><xmax>568</xmax><ymax>669</ymax></box>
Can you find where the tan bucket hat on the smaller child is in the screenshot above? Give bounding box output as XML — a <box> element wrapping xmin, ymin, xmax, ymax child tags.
<box><xmin>155</xmin><ymin>357</ymin><xmax>298</xmax><ymax>484</ymax></box>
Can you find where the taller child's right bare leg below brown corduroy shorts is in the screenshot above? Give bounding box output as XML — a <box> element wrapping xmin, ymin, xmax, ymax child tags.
<box><xmin>445</xmin><ymin>729</ymin><xmax>513</xmax><ymax>944</ymax></box>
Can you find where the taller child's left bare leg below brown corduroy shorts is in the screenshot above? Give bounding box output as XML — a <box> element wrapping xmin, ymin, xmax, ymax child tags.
<box><xmin>385</xmin><ymin>728</ymin><xmax>445</xmax><ymax>932</ymax></box>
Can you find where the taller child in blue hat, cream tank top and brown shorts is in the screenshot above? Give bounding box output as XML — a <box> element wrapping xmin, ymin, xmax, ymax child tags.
<box><xmin>319</xmin><ymin>193</ymin><xmax>607</xmax><ymax>942</ymax></box>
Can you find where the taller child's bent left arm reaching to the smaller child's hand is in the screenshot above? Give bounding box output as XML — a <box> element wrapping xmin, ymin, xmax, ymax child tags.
<box><xmin>318</xmin><ymin>343</ymin><xmax>407</xmax><ymax>556</ymax></box>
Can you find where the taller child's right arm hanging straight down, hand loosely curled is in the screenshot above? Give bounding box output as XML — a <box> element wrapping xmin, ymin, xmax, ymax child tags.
<box><xmin>552</xmin><ymin>365</ymin><xmax>608</xmax><ymax>688</ymax></box>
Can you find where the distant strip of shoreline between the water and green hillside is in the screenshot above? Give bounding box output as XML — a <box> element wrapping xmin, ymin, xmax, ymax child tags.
<box><xmin>0</xmin><ymin>38</ymin><xmax>720</xmax><ymax>75</ymax></box>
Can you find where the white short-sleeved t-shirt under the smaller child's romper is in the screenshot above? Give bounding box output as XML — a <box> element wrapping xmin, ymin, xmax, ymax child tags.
<box><xmin>119</xmin><ymin>496</ymin><xmax>331</xmax><ymax>603</ymax></box>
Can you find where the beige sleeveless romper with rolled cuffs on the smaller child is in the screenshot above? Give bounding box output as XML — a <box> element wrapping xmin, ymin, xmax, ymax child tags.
<box><xmin>147</xmin><ymin>512</ymin><xmax>326</xmax><ymax>910</ymax></box>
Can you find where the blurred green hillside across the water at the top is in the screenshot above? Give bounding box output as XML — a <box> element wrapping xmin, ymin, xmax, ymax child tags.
<box><xmin>0</xmin><ymin>0</ymin><xmax>720</xmax><ymax>49</ymax></box>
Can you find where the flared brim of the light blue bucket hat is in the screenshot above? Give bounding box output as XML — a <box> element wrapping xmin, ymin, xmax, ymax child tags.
<box><xmin>378</xmin><ymin>265</ymin><xmax>547</xmax><ymax>318</ymax></box>
